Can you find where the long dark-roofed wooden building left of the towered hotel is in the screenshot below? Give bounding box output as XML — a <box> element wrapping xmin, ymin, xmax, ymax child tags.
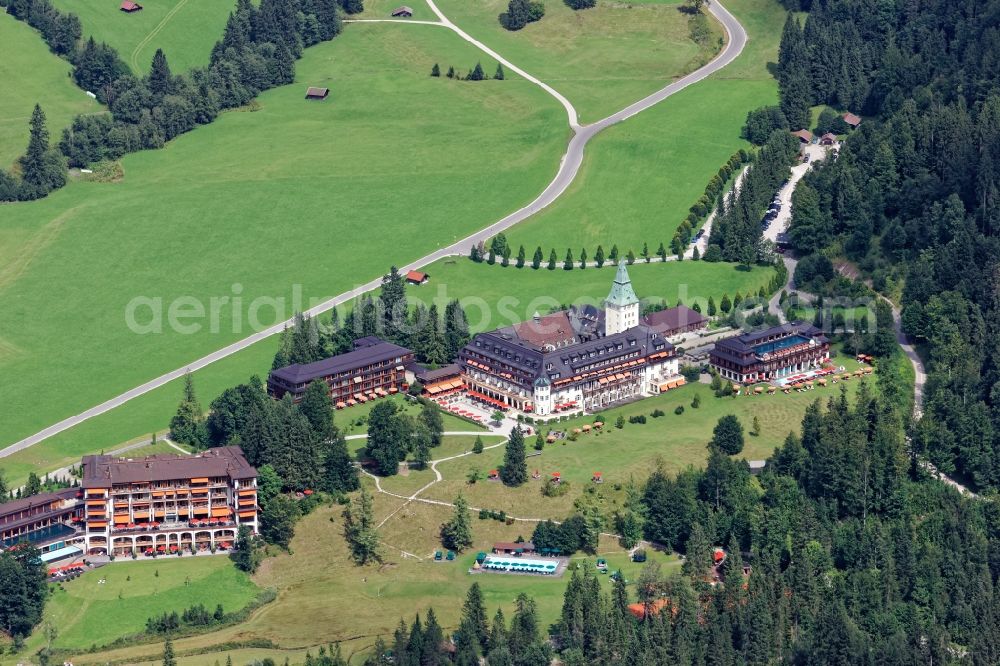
<box><xmin>267</xmin><ymin>337</ymin><xmax>413</xmax><ymax>407</ymax></box>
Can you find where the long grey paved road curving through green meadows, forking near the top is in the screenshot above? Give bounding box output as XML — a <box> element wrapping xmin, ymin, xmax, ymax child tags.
<box><xmin>0</xmin><ymin>0</ymin><xmax>747</xmax><ymax>458</ymax></box>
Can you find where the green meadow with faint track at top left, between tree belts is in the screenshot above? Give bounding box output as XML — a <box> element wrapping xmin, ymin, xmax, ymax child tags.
<box><xmin>52</xmin><ymin>0</ymin><xmax>236</xmax><ymax>74</ymax></box>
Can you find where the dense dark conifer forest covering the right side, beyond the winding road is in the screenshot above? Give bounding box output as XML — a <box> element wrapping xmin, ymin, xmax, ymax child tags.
<box><xmin>779</xmin><ymin>0</ymin><xmax>1000</xmax><ymax>490</ymax></box>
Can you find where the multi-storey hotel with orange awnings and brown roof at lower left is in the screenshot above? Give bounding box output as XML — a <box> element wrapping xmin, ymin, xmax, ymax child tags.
<box><xmin>82</xmin><ymin>446</ymin><xmax>258</xmax><ymax>555</ymax></box>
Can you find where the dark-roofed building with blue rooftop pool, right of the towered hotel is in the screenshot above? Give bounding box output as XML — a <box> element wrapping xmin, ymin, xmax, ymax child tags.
<box><xmin>709</xmin><ymin>322</ymin><xmax>830</xmax><ymax>384</ymax></box>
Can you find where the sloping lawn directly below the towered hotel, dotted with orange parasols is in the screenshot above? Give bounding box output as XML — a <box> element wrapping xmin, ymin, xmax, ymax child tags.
<box><xmin>421</xmin><ymin>348</ymin><xmax>873</xmax><ymax>519</ymax></box>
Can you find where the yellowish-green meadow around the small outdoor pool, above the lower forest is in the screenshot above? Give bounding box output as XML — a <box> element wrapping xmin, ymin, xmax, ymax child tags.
<box><xmin>72</xmin><ymin>495</ymin><xmax>678</xmax><ymax>664</ymax></box>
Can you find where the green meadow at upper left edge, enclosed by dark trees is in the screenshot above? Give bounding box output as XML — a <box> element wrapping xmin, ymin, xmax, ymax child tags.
<box><xmin>0</xmin><ymin>11</ymin><xmax>102</xmax><ymax>169</ymax></box>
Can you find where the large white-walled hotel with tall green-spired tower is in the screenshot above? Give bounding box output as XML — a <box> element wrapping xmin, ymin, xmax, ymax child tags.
<box><xmin>458</xmin><ymin>263</ymin><xmax>684</xmax><ymax>416</ymax></box>
